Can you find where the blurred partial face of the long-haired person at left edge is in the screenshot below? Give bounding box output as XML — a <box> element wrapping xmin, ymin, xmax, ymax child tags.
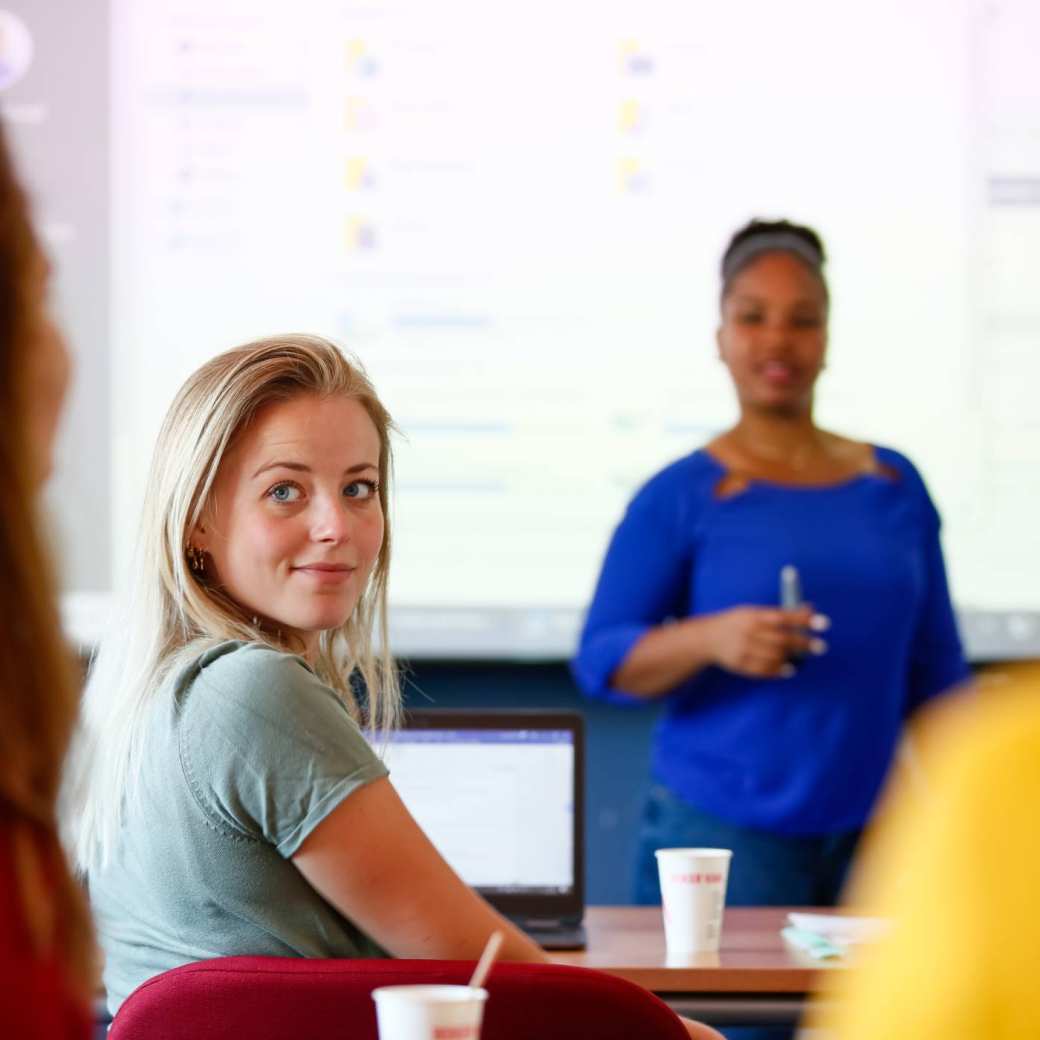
<box><xmin>22</xmin><ymin>255</ymin><xmax>72</xmax><ymax>485</ymax></box>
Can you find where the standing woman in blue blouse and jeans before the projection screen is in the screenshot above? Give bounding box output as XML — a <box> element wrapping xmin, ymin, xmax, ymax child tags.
<box><xmin>572</xmin><ymin>220</ymin><xmax>967</xmax><ymax>906</ymax></box>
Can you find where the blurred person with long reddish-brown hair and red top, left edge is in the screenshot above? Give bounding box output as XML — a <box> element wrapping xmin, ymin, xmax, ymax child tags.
<box><xmin>0</xmin><ymin>123</ymin><xmax>94</xmax><ymax>1040</ymax></box>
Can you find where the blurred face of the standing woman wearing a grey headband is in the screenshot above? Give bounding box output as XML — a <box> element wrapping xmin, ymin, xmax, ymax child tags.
<box><xmin>718</xmin><ymin>252</ymin><xmax>827</xmax><ymax>412</ymax></box>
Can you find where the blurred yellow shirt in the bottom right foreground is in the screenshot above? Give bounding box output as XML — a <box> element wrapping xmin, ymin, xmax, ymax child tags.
<box><xmin>809</xmin><ymin>670</ymin><xmax>1040</xmax><ymax>1040</ymax></box>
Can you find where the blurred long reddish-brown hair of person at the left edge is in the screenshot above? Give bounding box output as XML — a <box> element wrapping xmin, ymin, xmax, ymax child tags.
<box><xmin>0</xmin><ymin>128</ymin><xmax>94</xmax><ymax>999</ymax></box>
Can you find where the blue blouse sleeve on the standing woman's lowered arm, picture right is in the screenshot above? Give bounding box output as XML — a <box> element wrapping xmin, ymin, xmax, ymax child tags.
<box><xmin>906</xmin><ymin>472</ymin><xmax>970</xmax><ymax>714</ymax></box>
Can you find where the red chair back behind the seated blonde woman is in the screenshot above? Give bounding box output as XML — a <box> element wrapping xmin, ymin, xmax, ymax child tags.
<box><xmin>108</xmin><ymin>957</ymin><xmax>688</xmax><ymax>1040</ymax></box>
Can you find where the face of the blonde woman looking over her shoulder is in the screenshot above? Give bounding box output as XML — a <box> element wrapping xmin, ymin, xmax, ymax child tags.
<box><xmin>192</xmin><ymin>394</ymin><xmax>384</xmax><ymax>656</ymax></box>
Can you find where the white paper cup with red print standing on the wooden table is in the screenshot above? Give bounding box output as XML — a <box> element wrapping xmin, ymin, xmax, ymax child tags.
<box><xmin>654</xmin><ymin>849</ymin><xmax>733</xmax><ymax>955</ymax></box>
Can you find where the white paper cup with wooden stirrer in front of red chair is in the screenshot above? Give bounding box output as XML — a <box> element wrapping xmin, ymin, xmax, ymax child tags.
<box><xmin>372</xmin><ymin>986</ymin><xmax>488</xmax><ymax>1040</ymax></box>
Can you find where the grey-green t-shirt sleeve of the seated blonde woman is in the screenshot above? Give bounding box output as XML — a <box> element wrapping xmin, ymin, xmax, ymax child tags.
<box><xmin>179</xmin><ymin>647</ymin><xmax>387</xmax><ymax>858</ymax></box>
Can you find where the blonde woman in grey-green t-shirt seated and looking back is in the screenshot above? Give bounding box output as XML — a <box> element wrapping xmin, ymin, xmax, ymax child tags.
<box><xmin>72</xmin><ymin>336</ymin><xmax>717</xmax><ymax>1037</ymax></box>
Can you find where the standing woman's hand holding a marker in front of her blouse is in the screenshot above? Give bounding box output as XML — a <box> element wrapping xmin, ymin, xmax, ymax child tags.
<box><xmin>705</xmin><ymin>603</ymin><xmax>828</xmax><ymax>678</ymax></box>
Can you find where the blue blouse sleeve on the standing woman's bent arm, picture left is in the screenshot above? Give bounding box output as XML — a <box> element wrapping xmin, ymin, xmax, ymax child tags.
<box><xmin>571</xmin><ymin>482</ymin><xmax>693</xmax><ymax>703</ymax></box>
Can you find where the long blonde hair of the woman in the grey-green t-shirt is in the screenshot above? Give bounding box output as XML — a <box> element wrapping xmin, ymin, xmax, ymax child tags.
<box><xmin>67</xmin><ymin>335</ymin><xmax>400</xmax><ymax>875</ymax></box>
